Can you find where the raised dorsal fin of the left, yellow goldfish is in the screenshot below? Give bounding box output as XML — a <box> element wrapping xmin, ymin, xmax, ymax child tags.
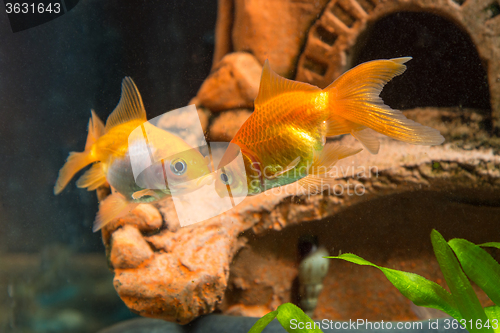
<box><xmin>106</xmin><ymin>76</ymin><xmax>147</xmax><ymax>131</ymax></box>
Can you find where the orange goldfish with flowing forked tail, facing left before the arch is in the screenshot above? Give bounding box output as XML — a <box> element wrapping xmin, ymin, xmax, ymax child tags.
<box><xmin>215</xmin><ymin>57</ymin><xmax>444</xmax><ymax>196</ymax></box>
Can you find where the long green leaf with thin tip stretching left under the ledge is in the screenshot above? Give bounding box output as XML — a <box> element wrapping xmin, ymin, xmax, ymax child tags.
<box><xmin>327</xmin><ymin>253</ymin><xmax>462</xmax><ymax>320</ymax></box>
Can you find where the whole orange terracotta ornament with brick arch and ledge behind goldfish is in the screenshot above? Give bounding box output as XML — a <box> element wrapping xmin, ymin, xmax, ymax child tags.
<box><xmin>102</xmin><ymin>0</ymin><xmax>500</xmax><ymax>324</ymax></box>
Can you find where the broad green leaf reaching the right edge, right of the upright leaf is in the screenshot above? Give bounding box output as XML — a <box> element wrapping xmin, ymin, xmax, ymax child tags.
<box><xmin>448</xmin><ymin>238</ymin><xmax>500</xmax><ymax>305</ymax></box>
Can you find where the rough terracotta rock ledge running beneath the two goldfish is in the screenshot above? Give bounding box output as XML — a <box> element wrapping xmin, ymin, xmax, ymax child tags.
<box><xmin>103</xmin><ymin>105</ymin><xmax>500</xmax><ymax>323</ymax></box>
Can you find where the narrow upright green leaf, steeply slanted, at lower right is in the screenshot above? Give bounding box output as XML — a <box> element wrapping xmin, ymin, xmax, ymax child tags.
<box><xmin>431</xmin><ymin>230</ymin><xmax>493</xmax><ymax>333</ymax></box>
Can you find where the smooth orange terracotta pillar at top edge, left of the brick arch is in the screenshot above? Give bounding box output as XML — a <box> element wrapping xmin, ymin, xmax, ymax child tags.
<box><xmin>214</xmin><ymin>0</ymin><xmax>327</xmax><ymax>77</ymax></box>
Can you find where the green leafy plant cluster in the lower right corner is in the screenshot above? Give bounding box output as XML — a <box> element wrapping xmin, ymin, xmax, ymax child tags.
<box><xmin>327</xmin><ymin>230</ymin><xmax>500</xmax><ymax>333</ymax></box>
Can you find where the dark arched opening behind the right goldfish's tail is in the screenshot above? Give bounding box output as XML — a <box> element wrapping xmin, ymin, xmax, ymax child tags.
<box><xmin>349</xmin><ymin>12</ymin><xmax>491</xmax><ymax>115</ymax></box>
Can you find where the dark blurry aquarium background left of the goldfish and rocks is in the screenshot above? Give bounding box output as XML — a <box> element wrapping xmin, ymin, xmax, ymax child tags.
<box><xmin>0</xmin><ymin>0</ymin><xmax>217</xmax><ymax>332</ymax></box>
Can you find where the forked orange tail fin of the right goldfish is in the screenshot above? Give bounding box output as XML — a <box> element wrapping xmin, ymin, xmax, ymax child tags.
<box><xmin>324</xmin><ymin>57</ymin><xmax>444</xmax><ymax>148</ymax></box>
